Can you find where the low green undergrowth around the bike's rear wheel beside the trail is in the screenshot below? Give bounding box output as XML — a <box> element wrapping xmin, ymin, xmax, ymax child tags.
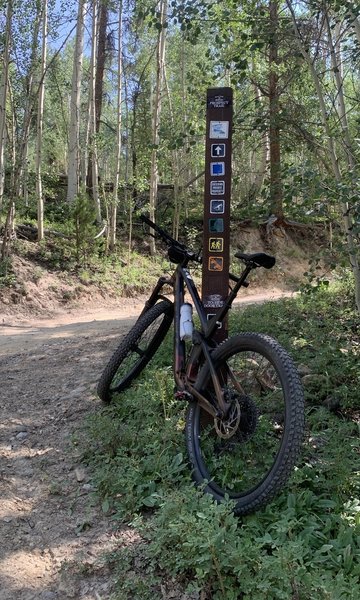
<box><xmin>86</xmin><ymin>284</ymin><xmax>360</xmax><ymax>600</ymax></box>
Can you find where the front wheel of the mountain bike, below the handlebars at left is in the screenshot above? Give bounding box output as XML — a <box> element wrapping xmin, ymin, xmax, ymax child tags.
<box><xmin>97</xmin><ymin>300</ymin><xmax>174</xmax><ymax>403</ymax></box>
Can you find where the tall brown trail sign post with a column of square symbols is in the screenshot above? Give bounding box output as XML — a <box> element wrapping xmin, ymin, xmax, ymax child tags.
<box><xmin>202</xmin><ymin>88</ymin><xmax>233</xmax><ymax>341</ymax></box>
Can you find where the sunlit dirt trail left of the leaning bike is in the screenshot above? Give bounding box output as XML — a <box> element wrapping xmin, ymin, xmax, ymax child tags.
<box><xmin>0</xmin><ymin>293</ymin><xmax>292</xmax><ymax>600</ymax></box>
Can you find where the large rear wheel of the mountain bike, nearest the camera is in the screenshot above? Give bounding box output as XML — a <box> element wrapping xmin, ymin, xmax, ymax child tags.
<box><xmin>186</xmin><ymin>333</ymin><xmax>304</xmax><ymax>515</ymax></box>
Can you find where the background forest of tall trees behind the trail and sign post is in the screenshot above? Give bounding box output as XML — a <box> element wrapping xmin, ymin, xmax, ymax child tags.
<box><xmin>0</xmin><ymin>0</ymin><xmax>360</xmax><ymax>310</ymax></box>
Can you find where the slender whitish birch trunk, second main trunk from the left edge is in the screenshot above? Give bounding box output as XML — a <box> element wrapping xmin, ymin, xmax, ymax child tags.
<box><xmin>35</xmin><ymin>0</ymin><xmax>48</xmax><ymax>241</ymax></box>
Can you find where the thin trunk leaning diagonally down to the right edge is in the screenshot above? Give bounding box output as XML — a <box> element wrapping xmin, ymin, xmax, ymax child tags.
<box><xmin>286</xmin><ymin>0</ymin><xmax>360</xmax><ymax>313</ymax></box>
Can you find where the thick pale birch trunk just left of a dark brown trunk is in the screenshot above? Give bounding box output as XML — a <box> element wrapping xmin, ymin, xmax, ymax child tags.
<box><xmin>67</xmin><ymin>0</ymin><xmax>86</xmax><ymax>202</ymax></box>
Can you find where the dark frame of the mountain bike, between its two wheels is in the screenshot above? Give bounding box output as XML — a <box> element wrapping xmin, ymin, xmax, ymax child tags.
<box><xmin>141</xmin><ymin>260</ymin><xmax>254</xmax><ymax>417</ymax></box>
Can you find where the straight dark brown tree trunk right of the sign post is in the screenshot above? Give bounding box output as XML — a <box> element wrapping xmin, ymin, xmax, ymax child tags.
<box><xmin>269</xmin><ymin>0</ymin><xmax>284</xmax><ymax>219</ymax></box>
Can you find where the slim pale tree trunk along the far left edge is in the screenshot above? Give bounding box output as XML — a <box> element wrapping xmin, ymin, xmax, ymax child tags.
<box><xmin>0</xmin><ymin>0</ymin><xmax>13</xmax><ymax>210</ymax></box>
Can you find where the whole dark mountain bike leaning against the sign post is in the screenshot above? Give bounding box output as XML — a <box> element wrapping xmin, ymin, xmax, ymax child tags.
<box><xmin>97</xmin><ymin>216</ymin><xmax>304</xmax><ymax>515</ymax></box>
